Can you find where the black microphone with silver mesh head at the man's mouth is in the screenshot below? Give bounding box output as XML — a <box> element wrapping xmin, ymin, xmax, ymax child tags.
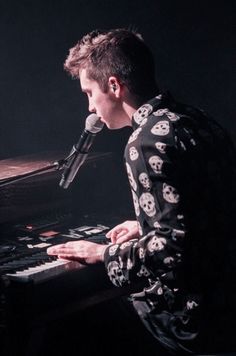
<box><xmin>59</xmin><ymin>114</ymin><xmax>104</xmax><ymax>189</ymax></box>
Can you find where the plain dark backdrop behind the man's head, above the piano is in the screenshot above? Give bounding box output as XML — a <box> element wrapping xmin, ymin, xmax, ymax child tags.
<box><xmin>0</xmin><ymin>0</ymin><xmax>236</xmax><ymax>159</ymax></box>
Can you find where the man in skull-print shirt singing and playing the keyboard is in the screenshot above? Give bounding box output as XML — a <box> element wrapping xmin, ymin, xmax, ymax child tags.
<box><xmin>48</xmin><ymin>29</ymin><xmax>235</xmax><ymax>355</ymax></box>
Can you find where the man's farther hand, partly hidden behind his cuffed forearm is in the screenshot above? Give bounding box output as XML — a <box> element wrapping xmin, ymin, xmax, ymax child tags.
<box><xmin>106</xmin><ymin>220</ymin><xmax>140</xmax><ymax>243</ymax></box>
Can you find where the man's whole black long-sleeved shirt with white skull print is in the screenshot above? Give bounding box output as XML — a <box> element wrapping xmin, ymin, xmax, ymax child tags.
<box><xmin>105</xmin><ymin>94</ymin><xmax>234</xmax><ymax>353</ymax></box>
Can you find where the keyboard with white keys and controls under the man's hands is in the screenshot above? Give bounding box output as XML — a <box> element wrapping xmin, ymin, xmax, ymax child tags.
<box><xmin>0</xmin><ymin>225</ymin><xmax>109</xmax><ymax>284</ymax></box>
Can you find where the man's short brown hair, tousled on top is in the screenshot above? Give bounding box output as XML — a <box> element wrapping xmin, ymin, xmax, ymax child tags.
<box><xmin>64</xmin><ymin>28</ymin><xmax>158</xmax><ymax>101</ymax></box>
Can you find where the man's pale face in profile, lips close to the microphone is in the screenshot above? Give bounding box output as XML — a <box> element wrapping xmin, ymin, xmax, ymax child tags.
<box><xmin>80</xmin><ymin>68</ymin><xmax>129</xmax><ymax>129</ymax></box>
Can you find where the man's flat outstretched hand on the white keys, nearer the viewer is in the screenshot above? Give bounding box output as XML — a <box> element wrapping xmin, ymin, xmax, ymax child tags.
<box><xmin>47</xmin><ymin>240</ymin><xmax>107</xmax><ymax>264</ymax></box>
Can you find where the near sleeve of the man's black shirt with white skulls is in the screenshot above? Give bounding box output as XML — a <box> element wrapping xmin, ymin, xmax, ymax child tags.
<box><xmin>104</xmin><ymin>112</ymin><xmax>186</xmax><ymax>286</ymax></box>
